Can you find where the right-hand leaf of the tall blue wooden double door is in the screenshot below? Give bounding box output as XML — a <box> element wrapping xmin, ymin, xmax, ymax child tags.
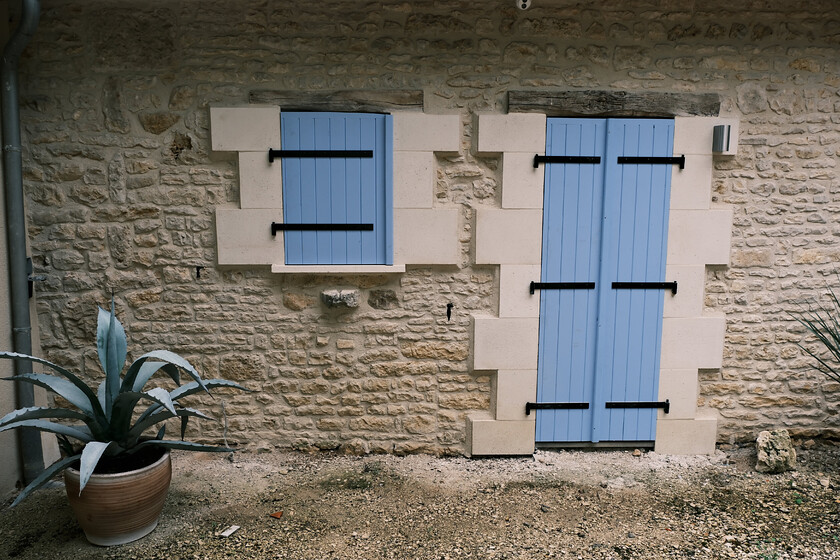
<box><xmin>593</xmin><ymin>119</ymin><xmax>674</xmax><ymax>441</ymax></box>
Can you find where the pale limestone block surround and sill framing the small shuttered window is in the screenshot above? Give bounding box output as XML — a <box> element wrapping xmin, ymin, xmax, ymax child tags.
<box><xmin>210</xmin><ymin>105</ymin><xmax>461</xmax><ymax>274</ymax></box>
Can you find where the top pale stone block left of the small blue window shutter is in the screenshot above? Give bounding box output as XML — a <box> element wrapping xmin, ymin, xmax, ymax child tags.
<box><xmin>210</xmin><ymin>106</ymin><xmax>280</xmax><ymax>151</ymax></box>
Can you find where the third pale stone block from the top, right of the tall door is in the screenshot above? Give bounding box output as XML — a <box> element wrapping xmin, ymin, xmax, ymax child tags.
<box><xmin>667</xmin><ymin>208</ymin><xmax>732</xmax><ymax>266</ymax></box>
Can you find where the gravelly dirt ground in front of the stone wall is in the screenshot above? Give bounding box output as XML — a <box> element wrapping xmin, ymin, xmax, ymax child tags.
<box><xmin>0</xmin><ymin>442</ymin><xmax>840</xmax><ymax>560</ymax></box>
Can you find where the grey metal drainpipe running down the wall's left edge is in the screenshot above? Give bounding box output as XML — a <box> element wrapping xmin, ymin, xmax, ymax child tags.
<box><xmin>0</xmin><ymin>0</ymin><xmax>44</xmax><ymax>482</ymax></box>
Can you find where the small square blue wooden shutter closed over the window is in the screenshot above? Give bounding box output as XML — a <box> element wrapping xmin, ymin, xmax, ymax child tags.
<box><xmin>281</xmin><ymin>112</ymin><xmax>393</xmax><ymax>265</ymax></box>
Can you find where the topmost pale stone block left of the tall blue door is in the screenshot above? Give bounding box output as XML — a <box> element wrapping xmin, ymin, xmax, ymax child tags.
<box><xmin>477</xmin><ymin>113</ymin><xmax>546</xmax><ymax>154</ymax></box>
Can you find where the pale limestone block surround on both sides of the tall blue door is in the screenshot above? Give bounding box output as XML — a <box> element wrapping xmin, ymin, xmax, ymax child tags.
<box><xmin>467</xmin><ymin>113</ymin><xmax>738</xmax><ymax>456</ymax></box>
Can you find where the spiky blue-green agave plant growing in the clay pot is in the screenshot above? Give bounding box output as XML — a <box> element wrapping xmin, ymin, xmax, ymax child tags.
<box><xmin>0</xmin><ymin>298</ymin><xmax>247</xmax><ymax>507</ymax></box>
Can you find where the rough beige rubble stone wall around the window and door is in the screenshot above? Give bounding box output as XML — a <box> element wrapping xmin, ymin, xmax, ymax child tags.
<box><xmin>16</xmin><ymin>0</ymin><xmax>840</xmax><ymax>453</ymax></box>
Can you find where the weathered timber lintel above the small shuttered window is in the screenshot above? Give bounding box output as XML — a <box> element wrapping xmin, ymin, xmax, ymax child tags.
<box><xmin>248</xmin><ymin>90</ymin><xmax>423</xmax><ymax>113</ymax></box>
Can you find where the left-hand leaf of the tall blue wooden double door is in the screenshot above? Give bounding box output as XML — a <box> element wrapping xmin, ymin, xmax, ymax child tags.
<box><xmin>537</xmin><ymin>119</ymin><xmax>606</xmax><ymax>441</ymax></box>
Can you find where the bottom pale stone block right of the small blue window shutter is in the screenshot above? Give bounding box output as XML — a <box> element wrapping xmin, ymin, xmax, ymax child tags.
<box><xmin>394</xmin><ymin>208</ymin><xmax>461</xmax><ymax>265</ymax></box>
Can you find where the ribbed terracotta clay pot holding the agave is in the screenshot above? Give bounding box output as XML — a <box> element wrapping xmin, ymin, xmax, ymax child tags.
<box><xmin>64</xmin><ymin>450</ymin><xmax>172</xmax><ymax>546</ymax></box>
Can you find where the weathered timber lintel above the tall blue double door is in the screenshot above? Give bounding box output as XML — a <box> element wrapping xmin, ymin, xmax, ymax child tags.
<box><xmin>508</xmin><ymin>90</ymin><xmax>720</xmax><ymax>117</ymax></box>
